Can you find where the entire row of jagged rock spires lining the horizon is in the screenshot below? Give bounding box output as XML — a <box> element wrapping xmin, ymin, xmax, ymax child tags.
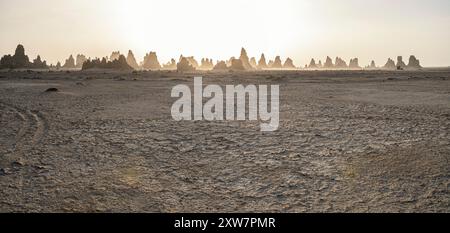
<box><xmin>0</xmin><ymin>45</ymin><xmax>422</xmax><ymax>72</ymax></box>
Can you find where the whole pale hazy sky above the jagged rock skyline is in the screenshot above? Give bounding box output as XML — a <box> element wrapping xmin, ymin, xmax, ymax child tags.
<box><xmin>0</xmin><ymin>0</ymin><xmax>450</xmax><ymax>66</ymax></box>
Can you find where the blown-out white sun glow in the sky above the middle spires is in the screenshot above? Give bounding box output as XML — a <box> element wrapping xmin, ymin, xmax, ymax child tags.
<box><xmin>112</xmin><ymin>0</ymin><xmax>308</xmax><ymax>60</ymax></box>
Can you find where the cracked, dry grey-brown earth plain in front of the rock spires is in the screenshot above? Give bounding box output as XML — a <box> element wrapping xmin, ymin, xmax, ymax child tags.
<box><xmin>0</xmin><ymin>70</ymin><xmax>450</xmax><ymax>212</ymax></box>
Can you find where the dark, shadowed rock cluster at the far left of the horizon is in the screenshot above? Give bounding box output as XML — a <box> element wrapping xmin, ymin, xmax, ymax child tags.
<box><xmin>0</xmin><ymin>44</ymin><xmax>48</xmax><ymax>69</ymax></box>
